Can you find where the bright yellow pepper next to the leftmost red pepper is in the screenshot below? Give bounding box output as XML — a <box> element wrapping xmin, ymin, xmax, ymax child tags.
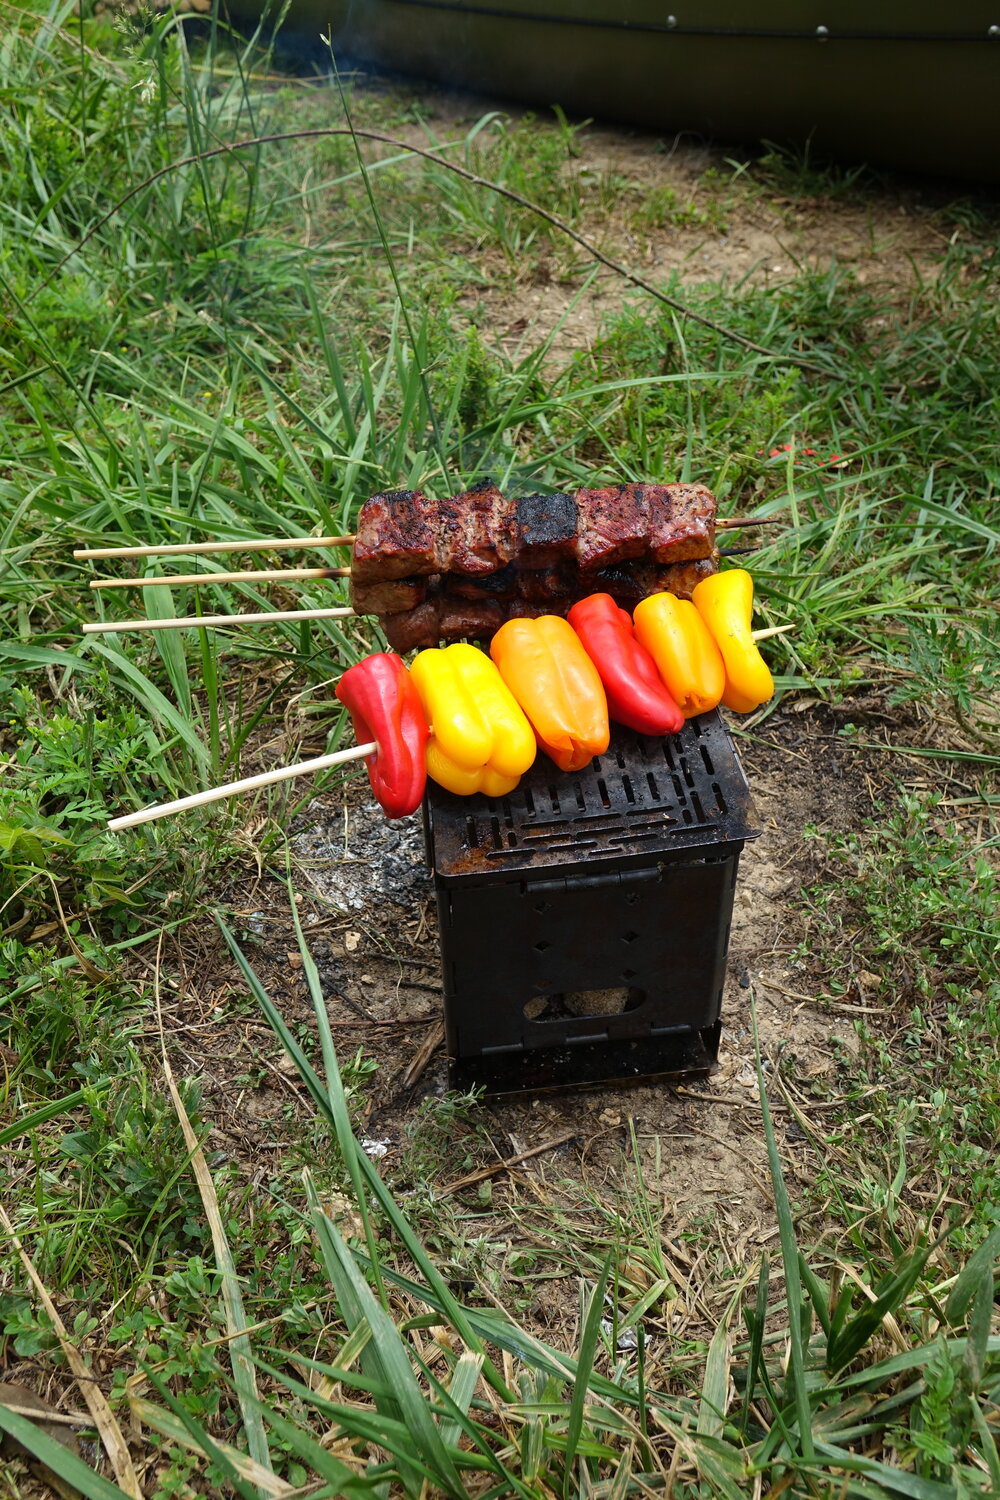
<box><xmin>409</xmin><ymin>642</ymin><xmax>537</xmax><ymax>797</ymax></box>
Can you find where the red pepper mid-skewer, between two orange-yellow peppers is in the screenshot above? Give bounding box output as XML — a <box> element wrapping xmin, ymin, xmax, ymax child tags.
<box><xmin>567</xmin><ymin>594</ymin><xmax>684</xmax><ymax>735</ymax></box>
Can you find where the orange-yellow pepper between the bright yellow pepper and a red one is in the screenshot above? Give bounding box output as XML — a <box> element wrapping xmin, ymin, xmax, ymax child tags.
<box><xmin>490</xmin><ymin>615</ymin><xmax>610</xmax><ymax>771</ymax></box>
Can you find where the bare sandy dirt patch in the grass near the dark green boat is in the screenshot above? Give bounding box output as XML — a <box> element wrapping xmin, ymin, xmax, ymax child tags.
<box><xmin>379</xmin><ymin>89</ymin><xmax>969</xmax><ymax>363</ymax></box>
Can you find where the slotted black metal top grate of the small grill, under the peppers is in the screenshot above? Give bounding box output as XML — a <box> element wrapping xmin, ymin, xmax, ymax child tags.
<box><xmin>427</xmin><ymin>713</ymin><xmax>753</xmax><ymax>884</ymax></box>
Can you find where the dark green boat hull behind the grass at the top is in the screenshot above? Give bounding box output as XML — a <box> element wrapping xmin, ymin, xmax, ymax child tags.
<box><xmin>234</xmin><ymin>0</ymin><xmax>1000</xmax><ymax>182</ymax></box>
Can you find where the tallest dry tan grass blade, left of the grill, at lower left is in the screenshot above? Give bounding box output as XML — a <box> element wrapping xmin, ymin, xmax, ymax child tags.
<box><xmin>153</xmin><ymin>938</ymin><xmax>271</xmax><ymax>1473</ymax></box>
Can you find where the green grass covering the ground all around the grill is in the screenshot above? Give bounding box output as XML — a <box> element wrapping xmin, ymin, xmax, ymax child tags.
<box><xmin>0</xmin><ymin>6</ymin><xmax>1000</xmax><ymax>1500</ymax></box>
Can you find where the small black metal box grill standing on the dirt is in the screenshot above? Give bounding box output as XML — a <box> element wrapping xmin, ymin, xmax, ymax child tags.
<box><xmin>424</xmin><ymin>711</ymin><xmax>759</xmax><ymax>1094</ymax></box>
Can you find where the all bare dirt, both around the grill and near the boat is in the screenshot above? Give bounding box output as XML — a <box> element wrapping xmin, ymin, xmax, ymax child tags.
<box><xmin>138</xmin><ymin>95</ymin><xmax>983</xmax><ymax>1314</ymax></box>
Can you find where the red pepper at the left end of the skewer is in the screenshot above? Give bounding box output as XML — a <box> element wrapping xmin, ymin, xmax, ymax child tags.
<box><xmin>336</xmin><ymin>651</ymin><xmax>430</xmax><ymax>818</ymax></box>
